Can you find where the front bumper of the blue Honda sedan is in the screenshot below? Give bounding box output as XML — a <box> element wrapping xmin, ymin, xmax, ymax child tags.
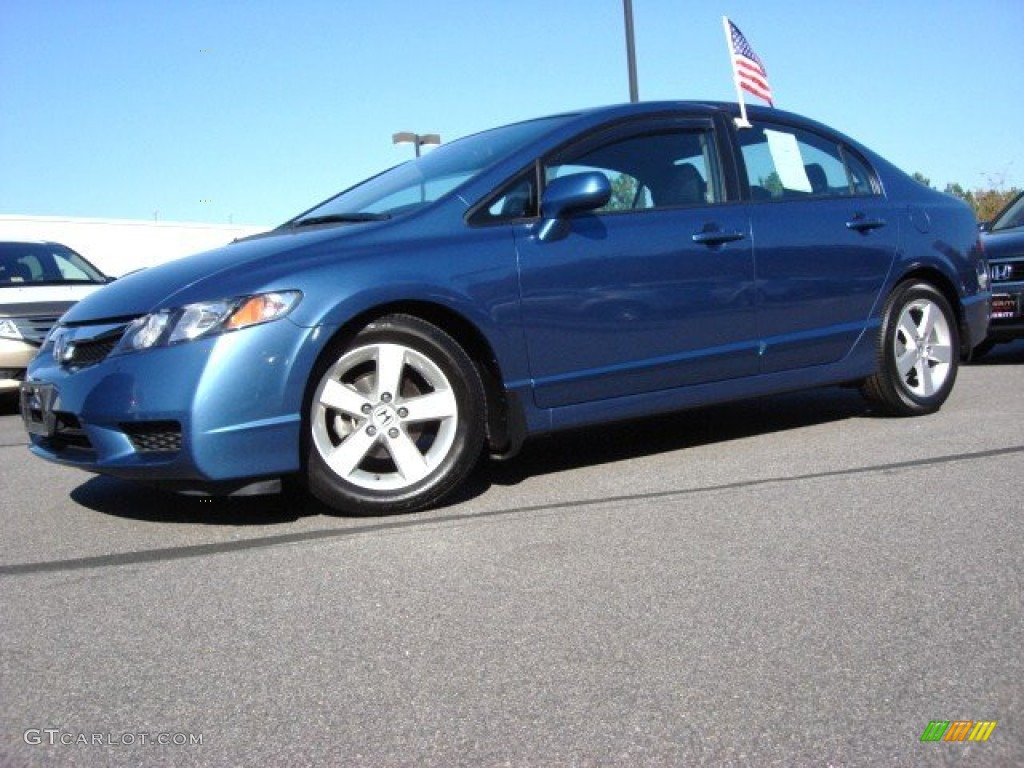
<box><xmin>22</xmin><ymin>318</ymin><xmax>318</xmax><ymax>489</ymax></box>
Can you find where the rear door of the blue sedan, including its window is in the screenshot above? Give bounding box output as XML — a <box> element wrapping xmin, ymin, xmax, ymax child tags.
<box><xmin>737</xmin><ymin>122</ymin><xmax>899</xmax><ymax>373</ymax></box>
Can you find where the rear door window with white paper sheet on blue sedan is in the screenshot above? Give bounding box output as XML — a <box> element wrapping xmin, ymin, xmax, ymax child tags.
<box><xmin>739</xmin><ymin>125</ymin><xmax>874</xmax><ymax>200</ymax></box>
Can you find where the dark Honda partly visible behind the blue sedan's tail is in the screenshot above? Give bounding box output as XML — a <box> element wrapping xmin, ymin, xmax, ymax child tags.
<box><xmin>974</xmin><ymin>193</ymin><xmax>1024</xmax><ymax>356</ymax></box>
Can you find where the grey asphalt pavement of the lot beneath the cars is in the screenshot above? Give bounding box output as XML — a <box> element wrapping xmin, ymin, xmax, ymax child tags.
<box><xmin>0</xmin><ymin>342</ymin><xmax>1024</xmax><ymax>766</ymax></box>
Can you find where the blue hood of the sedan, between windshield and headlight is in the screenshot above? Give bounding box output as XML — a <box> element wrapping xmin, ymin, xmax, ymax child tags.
<box><xmin>62</xmin><ymin>224</ymin><xmax>374</xmax><ymax>323</ymax></box>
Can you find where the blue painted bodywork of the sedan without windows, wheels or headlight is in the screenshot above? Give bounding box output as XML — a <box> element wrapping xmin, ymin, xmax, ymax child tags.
<box><xmin>24</xmin><ymin>103</ymin><xmax>988</xmax><ymax>493</ymax></box>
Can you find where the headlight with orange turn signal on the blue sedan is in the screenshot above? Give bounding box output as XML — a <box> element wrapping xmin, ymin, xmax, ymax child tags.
<box><xmin>115</xmin><ymin>291</ymin><xmax>302</xmax><ymax>353</ymax></box>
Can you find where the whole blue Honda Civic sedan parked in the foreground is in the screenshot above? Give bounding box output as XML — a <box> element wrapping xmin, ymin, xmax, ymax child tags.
<box><xmin>20</xmin><ymin>102</ymin><xmax>990</xmax><ymax>514</ymax></box>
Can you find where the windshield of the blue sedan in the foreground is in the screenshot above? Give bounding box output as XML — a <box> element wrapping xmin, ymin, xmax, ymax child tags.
<box><xmin>286</xmin><ymin>117</ymin><xmax>566</xmax><ymax>226</ymax></box>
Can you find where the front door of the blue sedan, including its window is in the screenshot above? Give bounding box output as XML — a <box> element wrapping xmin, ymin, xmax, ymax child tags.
<box><xmin>515</xmin><ymin>121</ymin><xmax>759</xmax><ymax>408</ymax></box>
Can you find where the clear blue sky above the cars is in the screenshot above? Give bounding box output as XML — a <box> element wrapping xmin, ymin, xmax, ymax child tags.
<box><xmin>0</xmin><ymin>0</ymin><xmax>1024</xmax><ymax>225</ymax></box>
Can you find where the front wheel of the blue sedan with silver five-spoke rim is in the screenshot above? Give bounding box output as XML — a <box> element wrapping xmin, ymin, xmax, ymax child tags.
<box><xmin>305</xmin><ymin>314</ymin><xmax>485</xmax><ymax>514</ymax></box>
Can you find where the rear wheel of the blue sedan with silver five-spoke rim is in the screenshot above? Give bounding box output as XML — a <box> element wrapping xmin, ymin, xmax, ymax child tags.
<box><xmin>863</xmin><ymin>282</ymin><xmax>959</xmax><ymax>416</ymax></box>
